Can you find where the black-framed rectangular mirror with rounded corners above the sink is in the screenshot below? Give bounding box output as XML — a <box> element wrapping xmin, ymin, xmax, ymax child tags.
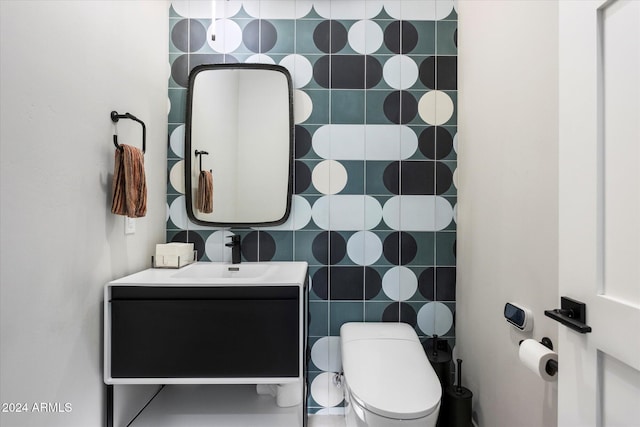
<box><xmin>185</xmin><ymin>64</ymin><xmax>293</xmax><ymax>227</ymax></box>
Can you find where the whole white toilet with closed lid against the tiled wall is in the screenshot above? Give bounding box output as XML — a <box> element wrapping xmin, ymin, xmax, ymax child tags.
<box><xmin>340</xmin><ymin>322</ymin><xmax>442</xmax><ymax>427</ymax></box>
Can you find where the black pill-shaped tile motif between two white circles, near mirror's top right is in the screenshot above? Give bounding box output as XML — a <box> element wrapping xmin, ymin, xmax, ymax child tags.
<box><xmin>313</xmin><ymin>55</ymin><xmax>382</xmax><ymax>89</ymax></box>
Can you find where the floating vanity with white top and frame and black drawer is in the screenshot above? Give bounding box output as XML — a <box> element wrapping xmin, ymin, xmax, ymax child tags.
<box><xmin>104</xmin><ymin>262</ymin><xmax>308</xmax><ymax>427</ymax></box>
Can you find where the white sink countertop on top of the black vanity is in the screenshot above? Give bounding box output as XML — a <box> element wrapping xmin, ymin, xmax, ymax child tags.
<box><xmin>108</xmin><ymin>261</ymin><xmax>308</xmax><ymax>286</ymax></box>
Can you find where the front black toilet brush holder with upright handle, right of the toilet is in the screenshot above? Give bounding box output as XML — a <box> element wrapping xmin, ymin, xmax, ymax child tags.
<box><xmin>437</xmin><ymin>359</ymin><xmax>473</xmax><ymax>427</ymax></box>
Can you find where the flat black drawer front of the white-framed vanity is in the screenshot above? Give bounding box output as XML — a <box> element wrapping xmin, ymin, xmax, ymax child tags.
<box><xmin>110</xmin><ymin>286</ymin><xmax>300</xmax><ymax>378</ymax></box>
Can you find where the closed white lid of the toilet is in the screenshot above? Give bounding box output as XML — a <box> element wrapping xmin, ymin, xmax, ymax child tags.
<box><xmin>342</xmin><ymin>339</ymin><xmax>442</xmax><ymax>419</ymax></box>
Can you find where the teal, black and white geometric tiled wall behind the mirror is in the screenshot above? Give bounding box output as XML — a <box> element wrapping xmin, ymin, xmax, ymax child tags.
<box><xmin>167</xmin><ymin>0</ymin><xmax>457</xmax><ymax>413</ymax></box>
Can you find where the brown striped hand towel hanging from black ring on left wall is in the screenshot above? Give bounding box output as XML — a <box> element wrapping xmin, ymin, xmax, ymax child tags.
<box><xmin>111</xmin><ymin>144</ymin><xmax>147</xmax><ymax>218</ymax></box>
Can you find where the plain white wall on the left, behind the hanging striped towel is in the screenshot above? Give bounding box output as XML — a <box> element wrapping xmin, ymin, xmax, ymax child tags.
<box><xmin>0</xmin><ymin>0</ymin><xmax>169</xmax><ymax>427</ymax></box>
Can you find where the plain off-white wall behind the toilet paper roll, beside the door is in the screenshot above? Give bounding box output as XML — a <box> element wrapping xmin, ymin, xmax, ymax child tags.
<box><xmin>456</xmin><ymin>0</ymin><xmax>562</xmax><ymax>427</ymax></box>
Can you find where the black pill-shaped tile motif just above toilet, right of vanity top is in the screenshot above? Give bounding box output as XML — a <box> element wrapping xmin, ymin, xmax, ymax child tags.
<box><xmin>312</xmin><ymin>266</ymin><xmax>382</xmax><ymax>301</ymax></box>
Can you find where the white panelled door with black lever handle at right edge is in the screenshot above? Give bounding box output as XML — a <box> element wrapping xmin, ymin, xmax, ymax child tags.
<box><xmin>558</xmin><ymin>0</ymin><xmax>640</xmax><ymax>427</ymax></box>
